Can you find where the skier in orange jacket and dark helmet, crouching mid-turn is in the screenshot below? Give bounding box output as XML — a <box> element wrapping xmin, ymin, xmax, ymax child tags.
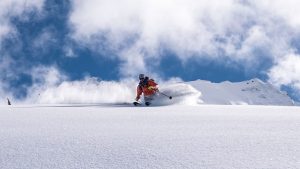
<box><xmin>133</xmin><ymin>74</ymin><xmax>158</xmax><ymax>106</ymax></box>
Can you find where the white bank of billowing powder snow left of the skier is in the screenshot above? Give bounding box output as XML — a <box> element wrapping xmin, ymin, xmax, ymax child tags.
<box><xmin>29</xmin><ymin>78</ymin><xmax>135</xmax><ymax>104</ymax></box>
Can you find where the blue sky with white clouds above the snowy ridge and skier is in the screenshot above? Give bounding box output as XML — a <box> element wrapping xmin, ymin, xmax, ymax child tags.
<box><xmin>0</xmin><ymin>0</ymin><xmax>300</xmax><ymax>100</ymax></box>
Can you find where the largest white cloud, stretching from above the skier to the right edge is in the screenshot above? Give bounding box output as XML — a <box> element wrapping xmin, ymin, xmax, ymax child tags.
<box><xmin>70</xmin><ymin>0</ymin><xmax>300</xmax><ymax>76</ymax></box>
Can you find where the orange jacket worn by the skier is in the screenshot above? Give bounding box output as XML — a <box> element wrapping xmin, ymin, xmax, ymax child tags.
<box><xmin>136</xmin><ymin>79</ymin><xmax>158</xmax><ymax>100</ymax></box>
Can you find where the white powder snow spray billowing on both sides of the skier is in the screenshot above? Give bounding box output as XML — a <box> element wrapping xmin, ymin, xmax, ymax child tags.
<box><xmin>26</xmin><ymin>74</ymin><xmax>201</xmax><ymax>106</ymax></box>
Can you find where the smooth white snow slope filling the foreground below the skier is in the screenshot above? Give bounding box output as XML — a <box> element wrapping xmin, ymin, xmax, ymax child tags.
<box><xmin>0</xmin><ymin>105</ymin><xmax>300</xmax><ymax>169</ymax></box>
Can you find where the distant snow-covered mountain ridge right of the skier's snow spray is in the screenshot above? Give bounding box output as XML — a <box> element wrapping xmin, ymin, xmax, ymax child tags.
<box><xmin>184</xmin><ymin>79</ymin><xmax>295</xmax><ymax>106</ymax></box>
